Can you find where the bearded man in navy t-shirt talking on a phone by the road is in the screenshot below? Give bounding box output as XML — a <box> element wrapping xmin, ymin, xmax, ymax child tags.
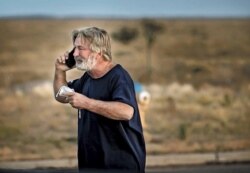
<box><xmin>54</xmin><ymin>27</ymin><xmax>146</xmax><ymax>172</ymax></box>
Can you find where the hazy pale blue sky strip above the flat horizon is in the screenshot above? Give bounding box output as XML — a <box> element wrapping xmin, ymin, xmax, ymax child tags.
<box><xmin>0</xmin><ymin>0</ymin><xmax>250</xmax><ymax>18</ymax></box>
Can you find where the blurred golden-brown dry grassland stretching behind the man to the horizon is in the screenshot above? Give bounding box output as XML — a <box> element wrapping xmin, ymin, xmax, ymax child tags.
<box><xmin>0</xmin><ymin>20</ymin><xmax>250</xmax><ymax>160</ymax></box>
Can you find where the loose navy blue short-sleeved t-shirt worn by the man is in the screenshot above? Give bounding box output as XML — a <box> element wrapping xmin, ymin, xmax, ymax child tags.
<box><xmin>68</xmin><ymin>64</ymin><xmax>146</xmax><ymax>172</ymax></box>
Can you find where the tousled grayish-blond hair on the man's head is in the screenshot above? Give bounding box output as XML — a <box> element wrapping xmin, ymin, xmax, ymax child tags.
<box><xmin>72</xmin><ymin>27</ymin><xmax>112</xmax><ymax>61</ymax></box>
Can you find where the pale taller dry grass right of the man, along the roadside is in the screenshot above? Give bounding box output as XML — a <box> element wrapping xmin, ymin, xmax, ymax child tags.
<box><xmin>146</xmin><ymin>84</ymin><xmax>250</xmax><ymax>153</ymax></box>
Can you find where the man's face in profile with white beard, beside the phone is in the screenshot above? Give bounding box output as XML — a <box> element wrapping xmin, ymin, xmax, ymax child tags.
<box><xmin>74</xmin><ymin>37</ymin><xmax>96</xmax><ymax>71</ymax></box>
